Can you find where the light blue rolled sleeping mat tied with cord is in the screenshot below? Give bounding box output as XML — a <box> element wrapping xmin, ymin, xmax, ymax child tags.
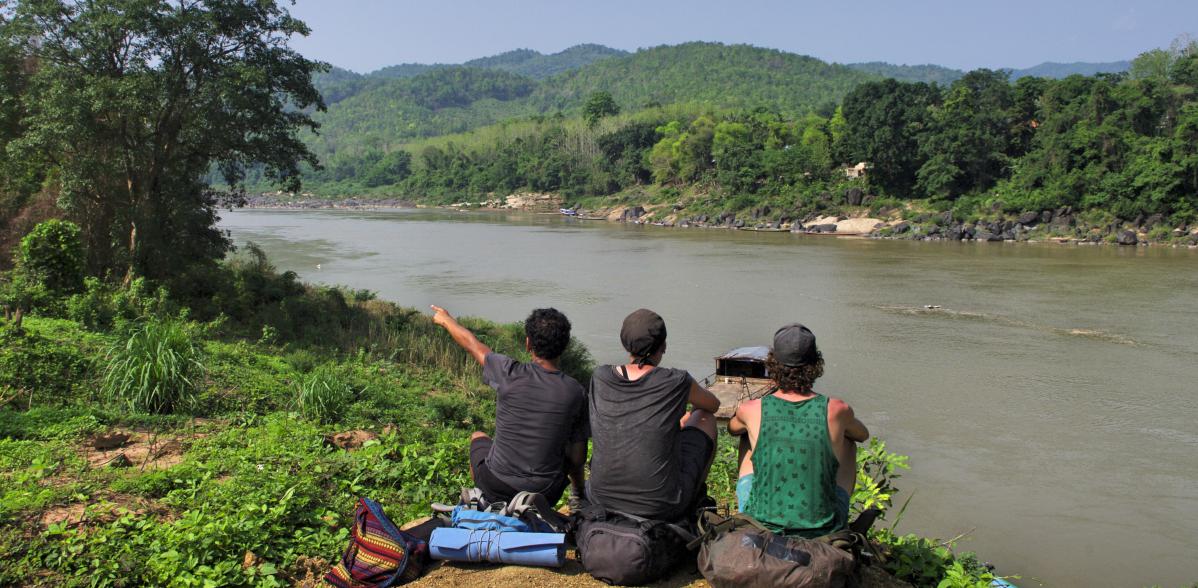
<box><xmin>429</xmin><ymin>527</ymin><xmax>565</xmax><ymax>568</ymax></box>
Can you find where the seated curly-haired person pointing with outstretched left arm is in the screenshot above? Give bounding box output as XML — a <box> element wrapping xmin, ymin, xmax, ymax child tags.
<box><xmin>432</xmin><ymin>307</ymin><xmax>587</xmax><ymax>504</ymax></box>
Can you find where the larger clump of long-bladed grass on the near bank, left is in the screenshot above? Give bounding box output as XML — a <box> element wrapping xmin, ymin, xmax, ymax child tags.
<box><xmin>103</xmin><ymin>319</ymin><xmax>205</xmax><ymax>414</ymax></box>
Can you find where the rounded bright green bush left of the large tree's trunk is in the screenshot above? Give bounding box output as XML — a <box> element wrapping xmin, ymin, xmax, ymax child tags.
<box><xmin>17</xmin><ymin>219</ymin><xmax>86</xmax><ymax>293</ymax></box>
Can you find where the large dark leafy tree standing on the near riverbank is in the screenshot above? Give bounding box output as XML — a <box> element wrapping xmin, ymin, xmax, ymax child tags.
<box><xmin>5</xmin><ymin>0</ymin><xmax>323</xmax><ymax>278</ymax></box>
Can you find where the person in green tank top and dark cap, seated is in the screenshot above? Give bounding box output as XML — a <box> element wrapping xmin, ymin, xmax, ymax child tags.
<box><xmin>728</xmin><ymin>325</ymin><xmax>870</xmax><ymax>539</ymax></box>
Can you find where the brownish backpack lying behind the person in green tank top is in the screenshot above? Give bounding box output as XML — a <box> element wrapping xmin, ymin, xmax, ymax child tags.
<box><xmin>698</xmin><ymin>513</ymin><xmax>872</xmax><ymax>588</ymax></box>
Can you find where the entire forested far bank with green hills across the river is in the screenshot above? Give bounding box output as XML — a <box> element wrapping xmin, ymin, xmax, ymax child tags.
<box><xmin>228</xmin><ymin>41</ymin><xmax>1198</xmax><ymax>241</ymax></box>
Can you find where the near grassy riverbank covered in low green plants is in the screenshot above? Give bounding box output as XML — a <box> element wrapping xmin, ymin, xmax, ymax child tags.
<box><xmin>0</xmin><ymin>250</ymin><xmax>1001</xmax><ymax>586</ymax></box>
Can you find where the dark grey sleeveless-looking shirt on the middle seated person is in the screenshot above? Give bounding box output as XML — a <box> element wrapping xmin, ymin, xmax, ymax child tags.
<box><xmin>587</xmin><ymin>365</ymin><xmax>694</xmax><ymax>517</ymax></box>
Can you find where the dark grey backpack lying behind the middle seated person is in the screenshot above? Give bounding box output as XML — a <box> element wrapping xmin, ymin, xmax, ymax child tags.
<box><xmin>575</xmin><ymin>504</ymin><xmax>695</xmax><ymax>586</ymax></box>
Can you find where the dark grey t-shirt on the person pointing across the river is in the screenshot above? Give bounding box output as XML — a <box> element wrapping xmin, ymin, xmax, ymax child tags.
<box><xmin>483</xmin><ymin>353</ymin><xmax>586</xmax><ymax>492</ymax></box>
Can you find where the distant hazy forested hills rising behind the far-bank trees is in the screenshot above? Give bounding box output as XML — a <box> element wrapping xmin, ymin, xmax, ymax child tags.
<box><xmin>299</xmin><ymin>43</ymin><xmax>876</xmax><ymax>167</ymax></box>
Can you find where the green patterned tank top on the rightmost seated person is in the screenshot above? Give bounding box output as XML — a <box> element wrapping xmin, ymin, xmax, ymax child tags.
<box><xmin>745</xmin><ymin>394</ymin><xmax>840</xmax><ymax>538</ymax></box>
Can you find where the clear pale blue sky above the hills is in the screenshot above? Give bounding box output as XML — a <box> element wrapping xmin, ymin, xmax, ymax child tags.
<box><xmin>291</xmin><ymin>0</ymin><xmax>1198</xmax><ymax>72</ymax></box>
